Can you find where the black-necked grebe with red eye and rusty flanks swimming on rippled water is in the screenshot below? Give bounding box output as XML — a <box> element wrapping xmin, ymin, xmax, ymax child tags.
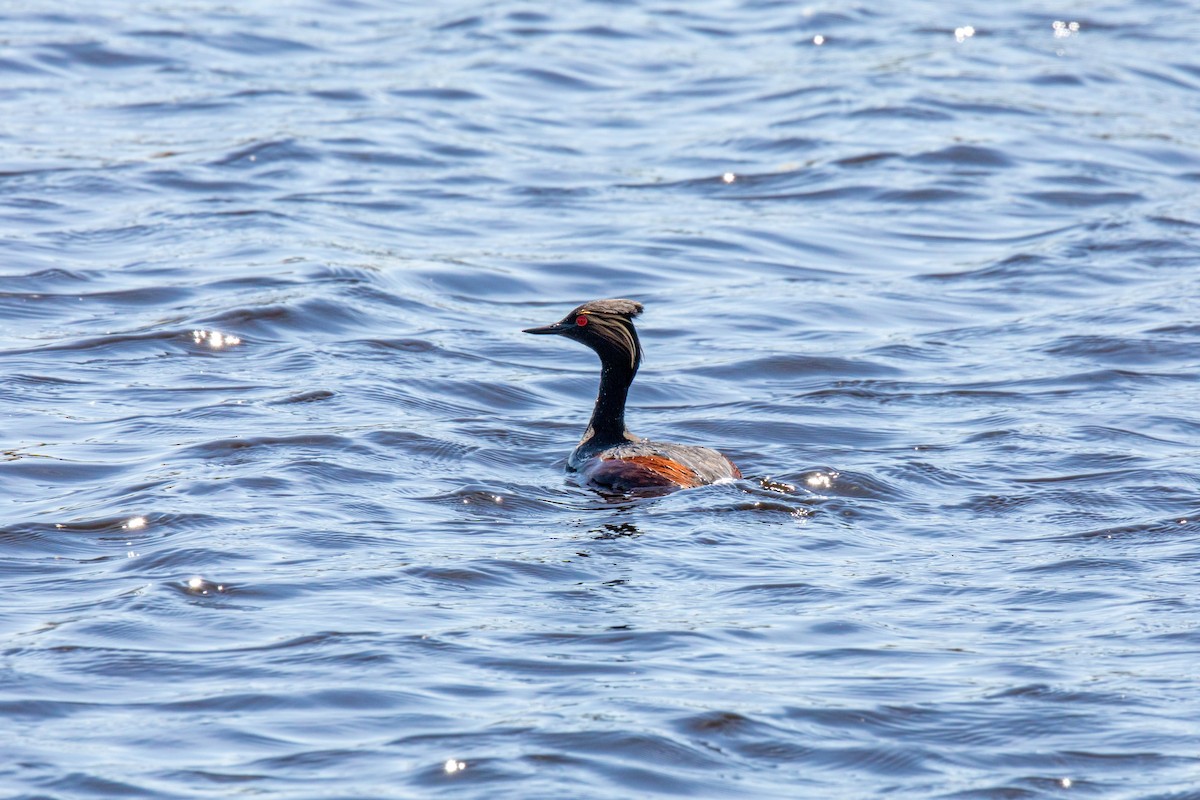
<box><xmin>524</xmin><ymin>300</ymin><xmax>742</xmax><ymax>493</ymax></box>
